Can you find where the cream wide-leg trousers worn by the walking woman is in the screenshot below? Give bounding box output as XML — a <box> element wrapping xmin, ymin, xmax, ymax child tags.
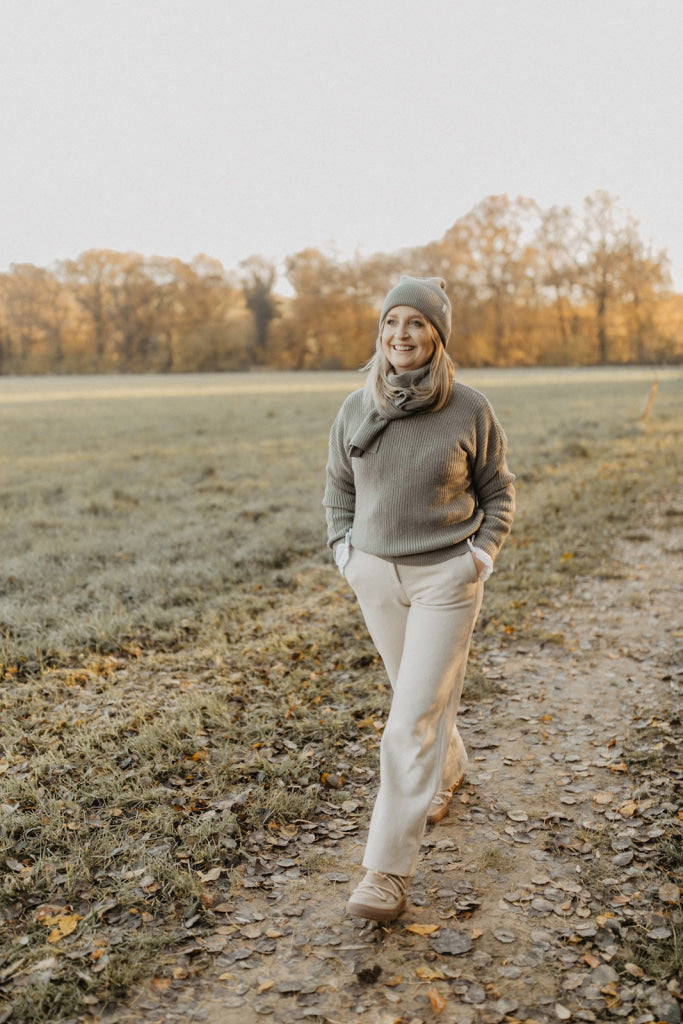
<box><xmin>344</xmin><ymin>548</ymin><xmax>483</xmax><ymax>876</ymax></box>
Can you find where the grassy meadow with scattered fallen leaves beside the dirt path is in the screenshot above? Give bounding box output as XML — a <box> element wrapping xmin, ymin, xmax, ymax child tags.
<box><xmin>0</xmin><ymin>368</ymin><xmax>683</xmax><ymax>1021</ymax></box>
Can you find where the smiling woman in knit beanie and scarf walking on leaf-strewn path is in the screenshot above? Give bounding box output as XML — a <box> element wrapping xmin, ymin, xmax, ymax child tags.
<box><xmin>323</xmin><ymin>276</ymin><xmax>514</xmax><ymax>921</ymax></box>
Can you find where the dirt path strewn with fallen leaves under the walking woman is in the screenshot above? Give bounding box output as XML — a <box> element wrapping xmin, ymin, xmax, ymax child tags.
<box><xmin>101</xmin><ymin>524</ymin><xmax>683</xmax><ymax>1024</ymax></box>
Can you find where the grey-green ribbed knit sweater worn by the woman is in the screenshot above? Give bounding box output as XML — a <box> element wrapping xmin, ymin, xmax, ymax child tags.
<box><xmin>323</xmin><ymin>382</ymin><xmax>515</xmax><ymax>565</ymax></box>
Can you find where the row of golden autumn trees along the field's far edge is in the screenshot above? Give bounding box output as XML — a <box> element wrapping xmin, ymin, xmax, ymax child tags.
<box><xmin>0</xmin><ymin>191</ymin><xmax>683</xmax><ymax>374</ymax></box>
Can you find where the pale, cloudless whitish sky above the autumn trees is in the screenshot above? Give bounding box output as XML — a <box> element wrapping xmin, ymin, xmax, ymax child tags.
<box><xmin>0</xmin><ymin>0</ymin><xmax>683</xmax><ymax>290</ymax></box>
